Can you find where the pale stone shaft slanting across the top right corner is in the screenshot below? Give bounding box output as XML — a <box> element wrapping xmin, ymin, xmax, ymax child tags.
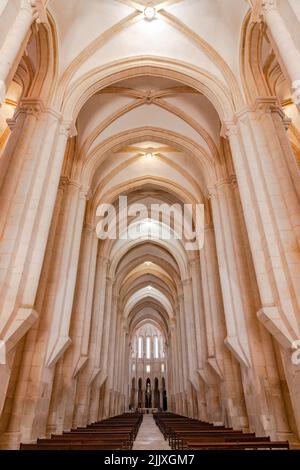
<box><xmin>262</xmin><ymin>0</ymin><xmax>300</xmax><ymax>105</ymax></box>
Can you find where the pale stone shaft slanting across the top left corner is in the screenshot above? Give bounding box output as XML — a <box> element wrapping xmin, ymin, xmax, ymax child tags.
<box><xmin>0</xmin><ymin>0</ymin><xmax>46</xmax><ymax>105</ymax></box>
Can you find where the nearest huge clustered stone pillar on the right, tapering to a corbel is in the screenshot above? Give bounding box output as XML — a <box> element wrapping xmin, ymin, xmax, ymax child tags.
<box><xmin>228</xmin><ymin>103</ymin><xmax>300</xmax><ymax>433</ymax></box>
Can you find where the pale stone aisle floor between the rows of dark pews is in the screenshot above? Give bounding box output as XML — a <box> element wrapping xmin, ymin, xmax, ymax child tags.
<box><xmin>133</xmin><ymin>414</ymin><xmax>171</xmax><ymax>450</ymax></box>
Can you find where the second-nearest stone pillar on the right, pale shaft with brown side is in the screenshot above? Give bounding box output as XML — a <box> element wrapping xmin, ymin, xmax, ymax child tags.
<box><xmin>211</xmin><ymin>177</ymin><xmax>288</xmax><ymax>438</ymax></box>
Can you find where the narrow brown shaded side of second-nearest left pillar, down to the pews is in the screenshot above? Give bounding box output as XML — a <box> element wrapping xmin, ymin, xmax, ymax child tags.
<box><xmin>1</xmin><ymin>182</ymin><xmax>65</xmax><ymax>449</ymax></box>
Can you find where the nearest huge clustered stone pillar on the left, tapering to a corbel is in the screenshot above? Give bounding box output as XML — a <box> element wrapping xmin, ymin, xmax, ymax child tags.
<box><xmin>0</xmin><ymin>100</ymin><xmax>70</xmax><ymax>411</ymax></box>
